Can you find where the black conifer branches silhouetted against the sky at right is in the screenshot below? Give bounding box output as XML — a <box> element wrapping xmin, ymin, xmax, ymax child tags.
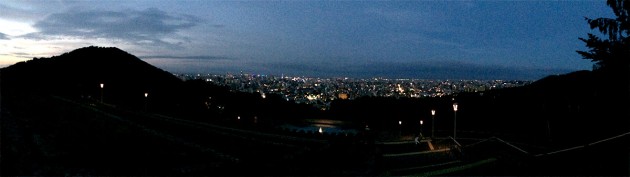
<box><xmin>577</xmin><ymin>0</ymin><xmax>630</xmax><ymax>73</ymax></box>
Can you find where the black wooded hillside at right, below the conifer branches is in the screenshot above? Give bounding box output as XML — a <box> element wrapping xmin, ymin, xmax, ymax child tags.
<box><xmin>456</xmin><ymin>71</ymin><xmax>630</xmax><ymax>145</ymax></box>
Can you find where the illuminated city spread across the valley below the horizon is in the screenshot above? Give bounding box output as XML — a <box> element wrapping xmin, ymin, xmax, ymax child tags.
<box><xmin>176</xmin><ymin>73</ymin><xmax>532</xmax><ymax>109</ymax></box>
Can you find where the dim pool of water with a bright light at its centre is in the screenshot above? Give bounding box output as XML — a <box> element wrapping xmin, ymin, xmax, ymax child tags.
<box><xmin>280</xmin><ymin>119</ymin><xmax>358</xmax><ymax>135</ymax></box>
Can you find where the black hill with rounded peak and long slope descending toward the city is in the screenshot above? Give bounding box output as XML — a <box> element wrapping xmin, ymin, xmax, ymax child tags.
<box><xmin>1</xmin><ymin>46</ymin><xmax>324</xmax><ymax>120</ymax></box>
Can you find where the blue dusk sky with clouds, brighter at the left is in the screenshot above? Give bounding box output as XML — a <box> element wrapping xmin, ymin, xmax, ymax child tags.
<box><xmin>0</xmin><ymin>0</ymin><xmax>613</xmax><ymax>80</ymax></box>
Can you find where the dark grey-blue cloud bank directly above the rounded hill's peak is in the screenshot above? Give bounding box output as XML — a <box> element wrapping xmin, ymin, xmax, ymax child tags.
<box><xmin>25</xmin><ymin>8</ymin><xmax>202</xmax><ymax>45</ymax></box>
